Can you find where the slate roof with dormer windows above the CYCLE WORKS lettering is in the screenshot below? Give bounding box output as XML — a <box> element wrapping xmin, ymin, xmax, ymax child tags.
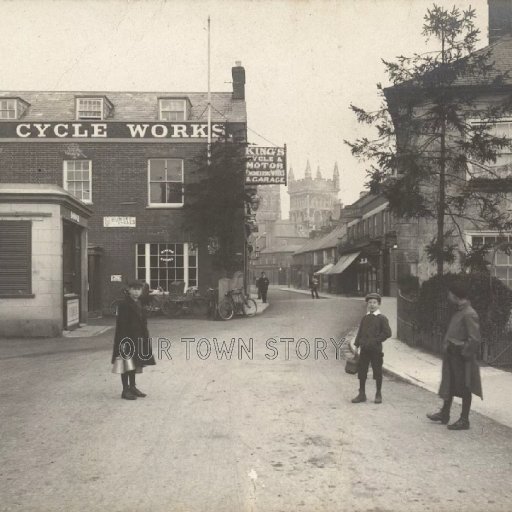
<box><xmin>0</xmin><ymin>91</ymin><xmax>247</xmax><ymax>123</ymax></box>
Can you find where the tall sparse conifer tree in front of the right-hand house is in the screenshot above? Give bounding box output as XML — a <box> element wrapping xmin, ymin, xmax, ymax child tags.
<box><xmin>345</xmin><ymin>5</ymin><xmax>512</xmax><ymax>275</ymax></box>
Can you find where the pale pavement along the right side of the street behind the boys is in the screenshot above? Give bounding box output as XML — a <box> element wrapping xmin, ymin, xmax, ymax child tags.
<box><xmin>281</xmin><ymin>288</ymin><xmax>512</xmax><ymax>428</ymax></box>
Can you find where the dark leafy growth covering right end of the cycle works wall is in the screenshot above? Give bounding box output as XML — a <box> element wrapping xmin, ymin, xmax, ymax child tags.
<box><xmin>184</xmin><ymin>140</ymin><xmax>249</xmax><ymax>273</ymax></box>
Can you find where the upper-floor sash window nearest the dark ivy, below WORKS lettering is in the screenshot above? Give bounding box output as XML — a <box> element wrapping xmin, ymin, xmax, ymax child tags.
<box><xmin>148</xmin><ymin>158</ymin><xmax>183</xmax><ymax>207</ymax></box>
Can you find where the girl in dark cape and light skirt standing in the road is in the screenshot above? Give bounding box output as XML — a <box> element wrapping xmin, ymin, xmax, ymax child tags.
<box><xmin>112</xmin><ymin>281</ymin><xmax>156</xmax><ymax>400</ymax></box>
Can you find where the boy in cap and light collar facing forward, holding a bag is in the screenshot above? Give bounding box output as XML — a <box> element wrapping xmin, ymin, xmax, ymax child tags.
<box><xmin>352</xmin><ymin>293</ymin><xmax>391</xmax><ymax>404</ymax></box>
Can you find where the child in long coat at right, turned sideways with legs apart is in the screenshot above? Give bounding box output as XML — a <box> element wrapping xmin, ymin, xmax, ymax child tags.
<box><xmin>427</xmin><ymin>282</ymin><xmax>483</xmax><ymax>430</ymax></box>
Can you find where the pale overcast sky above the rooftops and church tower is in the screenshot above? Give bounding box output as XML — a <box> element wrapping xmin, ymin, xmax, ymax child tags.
<box><xmin>0</xmin><ymin>0</ymin><xmax>487</xmax><ymax>218</ymax></box>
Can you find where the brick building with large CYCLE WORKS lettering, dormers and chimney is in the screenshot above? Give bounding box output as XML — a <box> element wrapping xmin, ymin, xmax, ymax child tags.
<box><xmin>0</xmin><ymin>63</ymin><xmax>246</xmax><ymax>320</ymax></box>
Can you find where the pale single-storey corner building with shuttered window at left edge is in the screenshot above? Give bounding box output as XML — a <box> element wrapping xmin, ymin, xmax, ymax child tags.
<box><xmin>0</xmin><ymin>183</ymin><xmax>92</xmax><ymax>337</ymax></box>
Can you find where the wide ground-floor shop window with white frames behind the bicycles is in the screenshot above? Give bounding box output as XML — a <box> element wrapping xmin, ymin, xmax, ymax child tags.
<box><xmin>137</xmin><ymin>243</ymin><xmax>198</xmax><ymax>291</ymax></box>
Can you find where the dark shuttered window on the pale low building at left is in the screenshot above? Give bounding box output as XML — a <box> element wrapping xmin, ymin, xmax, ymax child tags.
<box><xmin>0</xmin><ymin>220</ymin><xmax>32</xmax><ymax>296</ymax></box>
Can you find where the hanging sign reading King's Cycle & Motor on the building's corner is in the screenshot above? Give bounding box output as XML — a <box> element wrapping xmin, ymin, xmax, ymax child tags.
<box><xmin>245</xmin><ymin>146</ymin><xmax>286</xmax><ymax>185</ymax></box>
